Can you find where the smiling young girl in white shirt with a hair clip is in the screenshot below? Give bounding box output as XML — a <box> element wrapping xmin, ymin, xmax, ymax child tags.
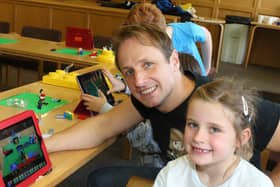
<box><xmin>154</xmin><ymin>78</ymin><xmax>273</xmax><ymax>187</ymax></box>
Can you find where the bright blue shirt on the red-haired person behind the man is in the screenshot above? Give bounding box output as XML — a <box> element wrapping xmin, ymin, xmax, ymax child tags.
<box><xmin>168</xmin><ymin>22</ymin><xmax>207</xmax><ymax>76</ymax></box>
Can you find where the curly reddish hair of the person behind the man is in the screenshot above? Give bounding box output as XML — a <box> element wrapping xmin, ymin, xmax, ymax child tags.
<box><xmin>124</xmin><ymin>3</ymin><xmax>166</xmax><ymax>30</ymax></box>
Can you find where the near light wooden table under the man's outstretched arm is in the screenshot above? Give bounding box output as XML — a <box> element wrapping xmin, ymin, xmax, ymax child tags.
<box><xmin>0</xmin><ymin>66</ymin><xmax>123</xmax><ymax>187</ymax></box>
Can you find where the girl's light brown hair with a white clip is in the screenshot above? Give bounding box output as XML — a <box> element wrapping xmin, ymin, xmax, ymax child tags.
<box><xmin>190</xmin><ymin>77</ymin><xmax>258</xmax><ymax>160</ymax></box>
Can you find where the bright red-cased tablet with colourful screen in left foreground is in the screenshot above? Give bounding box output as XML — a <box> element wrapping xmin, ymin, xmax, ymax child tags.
<box><xmin>0</xmin><ymin>110</ymin><xmax>51</xmax><ymax>187</ymax></box>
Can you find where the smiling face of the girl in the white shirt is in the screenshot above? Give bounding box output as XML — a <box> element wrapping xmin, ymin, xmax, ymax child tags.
<box><xmin>184</xmin><ymin>99</ymin><xmax>240</xmax><ymax>167</ymax></box>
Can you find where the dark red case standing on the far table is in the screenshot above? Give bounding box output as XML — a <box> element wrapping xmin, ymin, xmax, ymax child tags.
<box><xmin>66</xmin><ymin>27</ymin><xmax>93</xmax><ymax>50</ymax></box>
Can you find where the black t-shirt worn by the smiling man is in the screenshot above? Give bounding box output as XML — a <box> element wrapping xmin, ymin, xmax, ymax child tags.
<box><xmin>131</xmin><ymin>72</ymin><xmax>280</xmax><ymax>167</ymax></box>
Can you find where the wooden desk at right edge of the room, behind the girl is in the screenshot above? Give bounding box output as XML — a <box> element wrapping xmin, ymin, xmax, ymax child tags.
<box><xmin>244</xmin><ymin>22</ymin><xmax>280</xmax><ymax>68</ymax></box>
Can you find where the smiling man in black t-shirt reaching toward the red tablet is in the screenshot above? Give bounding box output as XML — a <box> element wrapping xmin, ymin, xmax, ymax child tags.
<box><xmin>45</xmin><ymin>23</ymin><xmax>280</xmax><ymax>187</ymax></box>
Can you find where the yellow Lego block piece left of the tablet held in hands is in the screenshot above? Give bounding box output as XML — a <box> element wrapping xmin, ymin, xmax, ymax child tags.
<box><xmin>42</xmin><ymin>70</ymin><xmax>79</xmax><ymax>89</ymax></box>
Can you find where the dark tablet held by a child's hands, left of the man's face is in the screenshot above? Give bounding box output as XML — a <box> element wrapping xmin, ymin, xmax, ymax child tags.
<box><xmin>77</xmin><ymin>69</ymin><xmax>115</xmax><ymax>105</ymax></box>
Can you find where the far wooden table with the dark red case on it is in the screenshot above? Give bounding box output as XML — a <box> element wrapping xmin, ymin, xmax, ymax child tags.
<box><xmin>0</xmin><ymin>33</ymin><xmax>101</xmax><ymax>86</ymax></box>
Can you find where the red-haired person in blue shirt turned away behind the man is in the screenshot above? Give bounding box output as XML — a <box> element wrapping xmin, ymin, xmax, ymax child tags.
<box><xmin>124</xmin><ymin>3</ymin><xmax>212</xmax><ymax>76</ymax></box>
